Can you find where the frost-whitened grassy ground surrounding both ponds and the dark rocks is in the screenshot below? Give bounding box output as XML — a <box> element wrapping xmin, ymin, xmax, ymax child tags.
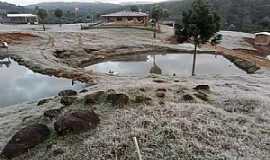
<box><xmin>0</xmin><ymin>25</ymin><xmax>270</xmax><ymax>160</ymax></box>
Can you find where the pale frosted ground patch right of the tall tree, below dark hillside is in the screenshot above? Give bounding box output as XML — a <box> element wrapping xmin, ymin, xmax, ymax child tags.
<box><xmin>219</xmin><ymin>31</ymin><xmax>256</xmax><ymax>50</ymax></box>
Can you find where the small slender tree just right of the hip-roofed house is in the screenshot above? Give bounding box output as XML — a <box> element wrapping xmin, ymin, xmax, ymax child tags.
<box><xmin>151</xmin><ymin>4</ymin><xmax>168</xmax><ymax>38</ymax></box>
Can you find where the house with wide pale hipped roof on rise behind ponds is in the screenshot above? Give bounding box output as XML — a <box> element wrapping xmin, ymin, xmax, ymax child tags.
<box><xmin>101</xmin><ymin>11</ymin><xmax>149</xmax><ymax>26</ymax></box>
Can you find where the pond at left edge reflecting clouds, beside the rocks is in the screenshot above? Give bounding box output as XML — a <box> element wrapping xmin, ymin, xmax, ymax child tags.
<box><xmin>0</xmin><ymin>58</ymin><xmax>84</xmax><ymax>107</ymax></box>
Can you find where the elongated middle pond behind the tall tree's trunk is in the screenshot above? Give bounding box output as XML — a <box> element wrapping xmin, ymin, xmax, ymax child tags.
<box><xmin>85</xmin><ymin>54</ymin><xmax>246</xmax><ymax>76</ymax></box>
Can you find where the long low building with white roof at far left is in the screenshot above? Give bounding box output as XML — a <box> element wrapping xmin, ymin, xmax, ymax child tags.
<box><xmin>5</xmin><ymin>14</ymin><xmax>38</xmax><ymax>24</ymax></box>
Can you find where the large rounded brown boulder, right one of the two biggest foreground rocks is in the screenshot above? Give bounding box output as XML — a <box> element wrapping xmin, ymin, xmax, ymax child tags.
<box><xmin>54</xmin><ymin>111</ymin><xmax>100</xmax><ymax>135</ymax></box>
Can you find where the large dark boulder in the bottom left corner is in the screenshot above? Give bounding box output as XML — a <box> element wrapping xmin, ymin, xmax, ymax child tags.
<box><xmin>1</xmin><ymin>124</ymin><xmax>50</xmax><ymax>159</ymax></box>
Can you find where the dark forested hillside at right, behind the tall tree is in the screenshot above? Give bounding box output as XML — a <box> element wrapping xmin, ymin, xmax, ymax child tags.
<box><xmin>151</xmin><ymin>0</ymin><xmax>270</xmax><ymax>32</ymax></box>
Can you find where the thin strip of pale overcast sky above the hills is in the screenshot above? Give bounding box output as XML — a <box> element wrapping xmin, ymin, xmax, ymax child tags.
<box><xmin>3</xmin><ymin>0</ymin><xmax>169</xmax><ymax>5</ymax></box>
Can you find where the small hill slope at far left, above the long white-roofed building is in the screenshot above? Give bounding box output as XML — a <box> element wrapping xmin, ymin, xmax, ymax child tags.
<box><xmin>0</xmin><ymin>2</ymin><xmax>30</xmax><ymax>14</ymax></box>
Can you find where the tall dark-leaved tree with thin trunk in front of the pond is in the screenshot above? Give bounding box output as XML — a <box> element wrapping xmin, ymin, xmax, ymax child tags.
<box><xmin>178</xmin><ymin>0</ymin><xmax>220</xmax><ymax>75</ymax></box>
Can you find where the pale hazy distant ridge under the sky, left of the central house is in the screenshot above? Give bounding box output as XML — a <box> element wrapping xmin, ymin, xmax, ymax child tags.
<box><xmin>26</xmin><ymin>2</ymin><xmax>120</xmax><ymax>14</ymax></box>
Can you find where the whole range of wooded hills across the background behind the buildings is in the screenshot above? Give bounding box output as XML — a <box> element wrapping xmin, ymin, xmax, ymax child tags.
<box><xmin>0</xmin><ymin>0</ymin><xmax>270</xmax><ymax>32</ymax></box>
